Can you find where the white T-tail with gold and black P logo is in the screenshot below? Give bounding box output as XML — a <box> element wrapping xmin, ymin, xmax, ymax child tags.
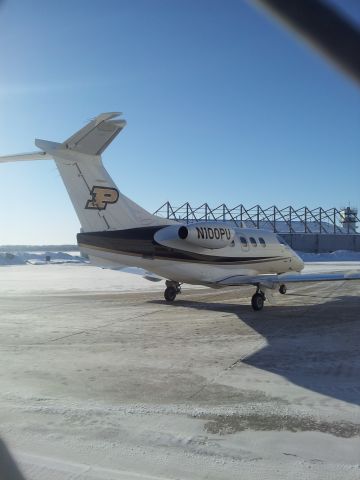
<box><xmin>0</xmin><ymin>112</ymin><xmax>171</xmax><ymax>232</ymax></box>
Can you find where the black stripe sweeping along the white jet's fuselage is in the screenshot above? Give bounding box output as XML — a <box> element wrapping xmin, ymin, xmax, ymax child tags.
<box><xmin>77</xmin><ymin>226</ymin><xmax>282</xmax><ymax>265</ymax></box>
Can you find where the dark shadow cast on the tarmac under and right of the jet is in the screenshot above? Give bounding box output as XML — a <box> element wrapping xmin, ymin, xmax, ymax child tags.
<box><xmin>152</xmin><ymin>293</ymin><xmax>360</xmax><ymax>405</ymax></box>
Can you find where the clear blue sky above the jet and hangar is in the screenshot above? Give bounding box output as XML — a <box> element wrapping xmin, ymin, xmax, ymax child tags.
<box><xmin>0</xmin><ymin>0</ymin><xmax>360</xmax><ymax>244</ymax></box>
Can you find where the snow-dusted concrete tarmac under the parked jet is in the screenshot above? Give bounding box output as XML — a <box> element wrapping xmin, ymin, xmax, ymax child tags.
<box><xmin>0</xmin><ymin>266</ymin><xmax>360</xmax><ymax>480</ymax></box>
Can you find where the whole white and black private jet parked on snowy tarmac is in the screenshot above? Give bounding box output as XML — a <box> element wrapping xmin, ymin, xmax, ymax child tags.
<box><xmin>0</xmin><ymin>112</ymin><xmax>360</xmax><ymax>311</ymax></box>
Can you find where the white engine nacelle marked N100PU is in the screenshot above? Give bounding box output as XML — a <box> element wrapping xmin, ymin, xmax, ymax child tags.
<box><xmin>178</xmin><ymin>222</ymin><xmax>235</xmax><ymax>248</ymax></box>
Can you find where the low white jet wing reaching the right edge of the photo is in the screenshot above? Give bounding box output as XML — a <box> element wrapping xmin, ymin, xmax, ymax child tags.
<box><xmin>216</xmin><ymin>270</ymin><xmax>360</xmax><ymax>288</ymax></box>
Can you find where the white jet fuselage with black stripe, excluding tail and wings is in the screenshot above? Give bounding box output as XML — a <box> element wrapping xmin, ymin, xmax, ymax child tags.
<box><xmin>78</xmin><ymin>222</ymin><xmax>304</xmax><ymax>286</ymax></box>
